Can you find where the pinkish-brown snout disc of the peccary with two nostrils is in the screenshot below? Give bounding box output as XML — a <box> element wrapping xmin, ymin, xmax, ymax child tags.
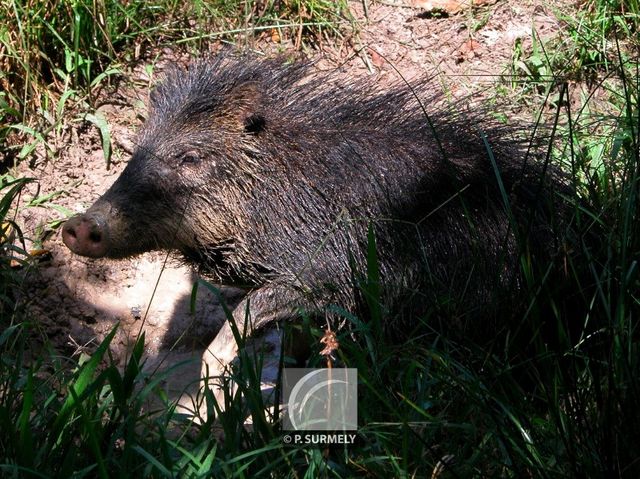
<box><xmin>62</xmin><ymin>214</ymin><xmax>108</xmax><ymax>258</ymax></box>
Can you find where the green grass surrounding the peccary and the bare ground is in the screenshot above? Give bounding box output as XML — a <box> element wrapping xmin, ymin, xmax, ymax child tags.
<box><xmin>0</xmin><ymin>1</ymin><xmax>640</xmax><ymax>478</ymax></box>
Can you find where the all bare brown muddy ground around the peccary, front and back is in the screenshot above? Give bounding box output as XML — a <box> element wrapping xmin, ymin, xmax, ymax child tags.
<box><xmin>11</xmin><ymin>0</ymin><xmax>561</xmax><ymax>408</ymax></box>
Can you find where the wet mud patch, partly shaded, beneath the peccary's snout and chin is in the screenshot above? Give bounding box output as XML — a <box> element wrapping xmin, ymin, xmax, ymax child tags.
<box><xmin>16</xmin><ymin>239</ymin><xmax>242</xmax><ymax>412</ymax></box>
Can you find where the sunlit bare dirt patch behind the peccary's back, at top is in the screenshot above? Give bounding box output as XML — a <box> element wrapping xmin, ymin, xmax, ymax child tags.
<box><xmin>332</xmin><ymin>1</ymin><xmax>560</xmax><ymax>89</ymax></box>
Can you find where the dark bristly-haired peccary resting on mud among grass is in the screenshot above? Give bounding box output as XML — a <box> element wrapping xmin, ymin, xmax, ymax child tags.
<box><xmin>62</xmin><ymin>54</ymin><xmax>559</xmax><ymax>390</ymax></box>
